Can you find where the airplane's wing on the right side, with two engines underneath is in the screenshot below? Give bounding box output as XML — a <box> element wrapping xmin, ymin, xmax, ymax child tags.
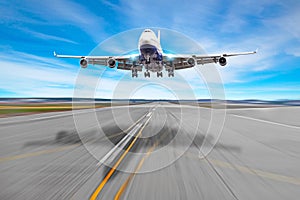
<box><xmin>164</xmin><ymin>50</ymin><xmax>257</xmax><ymax>70</ymax></box>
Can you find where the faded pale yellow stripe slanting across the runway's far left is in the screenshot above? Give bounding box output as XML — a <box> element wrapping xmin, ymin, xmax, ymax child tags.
<box><xmin>0</xmin><ymin>144</ymin><xmax>80</xmax><ymax>163</ymax></box>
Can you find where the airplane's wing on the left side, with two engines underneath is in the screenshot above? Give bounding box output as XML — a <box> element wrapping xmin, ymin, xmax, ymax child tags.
<box><xmin>54</xmin><ymin>52</ymin><xmax>136</xmax><ymax>70</ymax></box>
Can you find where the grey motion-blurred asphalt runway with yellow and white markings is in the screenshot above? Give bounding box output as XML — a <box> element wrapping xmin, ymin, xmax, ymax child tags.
<box><xmin>0</xmin><ymin>103</ymin><xmax>300</xmax><ymax>200</ymax></box>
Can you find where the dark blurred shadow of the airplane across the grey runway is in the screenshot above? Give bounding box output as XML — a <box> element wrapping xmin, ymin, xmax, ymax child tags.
<box><xmin>24</xmin><ymin>125</ymin><xmax>242</xmax><ymax>153</ymax></box>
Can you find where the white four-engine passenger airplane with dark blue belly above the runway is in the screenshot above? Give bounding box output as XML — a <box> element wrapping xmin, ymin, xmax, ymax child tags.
<box><xmin>54</xmin><ymin>29</ymin><xmax>257</xmax><ymax>77</ymax></box>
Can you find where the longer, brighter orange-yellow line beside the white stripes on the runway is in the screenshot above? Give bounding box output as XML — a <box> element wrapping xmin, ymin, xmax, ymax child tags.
<box><xmin>90</xmin><ymin>117</ymin><xmax>151</xmax><ymax>200</ymax></box>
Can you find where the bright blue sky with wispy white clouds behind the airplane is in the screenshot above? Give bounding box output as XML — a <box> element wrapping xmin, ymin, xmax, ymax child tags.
<box><xmin>0</xmin><ymin>0</ymin><xmax>300</xmax><ymax>100</ymax></box>
